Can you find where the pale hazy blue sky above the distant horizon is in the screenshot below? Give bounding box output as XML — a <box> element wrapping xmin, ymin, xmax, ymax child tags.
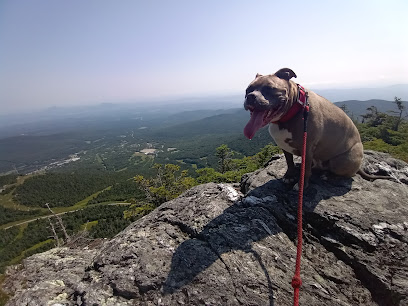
<box><xmin>0</xmin><ymin>0</ymin><xmax>408</xmax><ymax>113</ymax></box>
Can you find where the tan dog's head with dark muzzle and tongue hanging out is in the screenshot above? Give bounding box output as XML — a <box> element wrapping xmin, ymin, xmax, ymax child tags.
<box><xmin>244</xmin><ymin>69</ymin><xmax>296</xmax><ymax>139</ymax></box>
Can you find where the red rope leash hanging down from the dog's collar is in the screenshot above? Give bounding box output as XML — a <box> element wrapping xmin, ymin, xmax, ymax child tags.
<box><xmin>292</xmin><ymin>88</ymin><xmax>309</xmax><ymax>306</ymax></box>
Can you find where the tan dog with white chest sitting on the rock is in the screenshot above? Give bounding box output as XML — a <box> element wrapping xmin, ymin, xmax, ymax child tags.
<box><xmin>244</xmin><ymin>68</ymin><xmax>388</xmax><ymax>188</ymax></box>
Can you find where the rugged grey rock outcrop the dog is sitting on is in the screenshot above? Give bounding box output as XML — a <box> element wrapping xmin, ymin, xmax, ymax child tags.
<box><xmin>4</xmin><ymin>152</ymin><xmax>408</xmax><ymax>306</ymax></box>
